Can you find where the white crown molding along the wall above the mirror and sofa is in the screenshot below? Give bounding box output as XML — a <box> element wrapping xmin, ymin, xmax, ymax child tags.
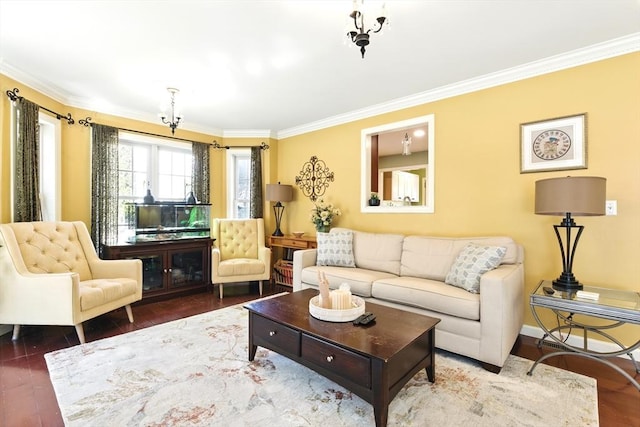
<box><xmin>277</xmin><ymin>33</ymin><xmax>640</xmax><ymax>139</ymax></box>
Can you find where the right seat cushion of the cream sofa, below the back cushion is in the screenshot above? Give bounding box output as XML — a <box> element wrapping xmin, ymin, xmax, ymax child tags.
<box><xmin>371</xmin><ymin>277</ymin><xmax>480</xmax><ymax>320</ymax></box>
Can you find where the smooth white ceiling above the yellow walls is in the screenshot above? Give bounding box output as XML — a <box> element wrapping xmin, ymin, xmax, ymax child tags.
<box><xmin>0</xmin><ymin>0</ymin><xmax>640</xmax><ymax>136</ymax></box>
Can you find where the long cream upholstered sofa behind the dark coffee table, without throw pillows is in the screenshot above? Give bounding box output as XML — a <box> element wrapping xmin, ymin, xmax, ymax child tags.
<box><xmin>293</xmin><ymin>228</ymin><xmax>524</xmax><ymax>372</ymax></box>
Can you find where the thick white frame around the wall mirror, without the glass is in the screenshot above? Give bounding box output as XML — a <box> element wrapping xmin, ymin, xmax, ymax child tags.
<box><xmin>360</xmin><ymin>114</ymin><xmax>435</xmax><ymax>214</ymax></box>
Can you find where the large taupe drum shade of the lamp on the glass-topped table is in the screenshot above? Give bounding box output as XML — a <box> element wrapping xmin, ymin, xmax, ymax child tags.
<box><xmin>535</xmin><ymin>176</ymin><xmax>607</xmax><ymax>216</ymax></box>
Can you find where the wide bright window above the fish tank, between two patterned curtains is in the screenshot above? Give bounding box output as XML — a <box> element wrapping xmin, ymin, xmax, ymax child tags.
<box><xmin>118</xmin><ymin>132</ymin><xmax>192</xmax><ymax>236</ymax></box>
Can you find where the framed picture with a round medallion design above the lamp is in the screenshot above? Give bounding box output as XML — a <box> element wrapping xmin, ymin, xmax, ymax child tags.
<box><xmin>520</xmin><ymin>113</ymin><xmax>587</xmax><ymax>173</ymax></box>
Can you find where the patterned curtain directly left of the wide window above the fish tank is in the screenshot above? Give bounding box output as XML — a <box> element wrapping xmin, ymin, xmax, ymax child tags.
<box><xmin>91</xmin><ymin>124</ymin><xmax>118</xmax><ymax>256</ymax></box>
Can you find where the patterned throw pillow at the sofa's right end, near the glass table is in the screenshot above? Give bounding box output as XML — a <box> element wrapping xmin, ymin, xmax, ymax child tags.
<box><xmin>444</xmin><ymin>243</ymin><xmax>507</xmax><ymax>294</ymax></box>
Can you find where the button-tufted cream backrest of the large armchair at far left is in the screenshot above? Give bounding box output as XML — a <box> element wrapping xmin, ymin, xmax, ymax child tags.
<box><xmin>6</xmin><ymin>222</ymin><xmax>93</xmax><ymax>281</ymax></box>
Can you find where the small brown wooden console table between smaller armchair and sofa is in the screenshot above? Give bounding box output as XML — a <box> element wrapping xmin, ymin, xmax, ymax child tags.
<box><xmin>269</xmin><ymin>235</ymin><xmax>317</xmax><ymax>291</ymax></box>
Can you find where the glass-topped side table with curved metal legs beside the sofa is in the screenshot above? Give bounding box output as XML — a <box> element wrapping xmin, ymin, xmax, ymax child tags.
<box><xmin>527</xmin><ymin>280</ymin><xmax>640</xmax><ymax>391</ymax></box>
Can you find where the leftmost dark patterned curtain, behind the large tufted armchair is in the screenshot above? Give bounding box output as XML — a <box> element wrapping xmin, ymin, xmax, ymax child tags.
<box><xmin>13</xmin><ymin>98</ymin><xmax>42</xmax><ymax>222</ymax></box>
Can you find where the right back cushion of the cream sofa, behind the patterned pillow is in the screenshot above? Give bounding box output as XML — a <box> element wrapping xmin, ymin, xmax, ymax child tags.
<box><xmin>400</xmin><ymin>236</ymin><xmax>522</xmax><ymax>282</ymax></box>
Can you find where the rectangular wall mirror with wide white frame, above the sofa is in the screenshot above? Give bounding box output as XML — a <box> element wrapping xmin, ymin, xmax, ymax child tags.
<box><xmin>360</xmin><ymin>114</ymin><xmax>435</xmax><ymax>213</ymax></box>
